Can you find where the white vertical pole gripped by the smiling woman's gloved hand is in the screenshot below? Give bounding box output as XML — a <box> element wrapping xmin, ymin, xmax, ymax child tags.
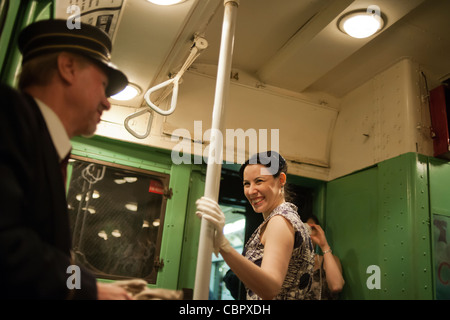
<box><xmin>194</xmin><ymin>0</ymin><xmax>239</xmax><ymax>300</ymax></box>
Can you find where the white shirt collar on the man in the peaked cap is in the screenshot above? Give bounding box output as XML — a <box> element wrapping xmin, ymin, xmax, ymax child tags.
<box><xmin>34</xmin><ymin>98</ymin><xmax>72</xmax><ymax>161</ymax></box>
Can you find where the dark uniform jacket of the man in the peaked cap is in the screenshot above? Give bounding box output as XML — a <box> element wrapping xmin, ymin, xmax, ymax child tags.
<box><xmin>0</xmin><ymin>84</ymin><xmax>97</xmax><ymax>299</ymax></box>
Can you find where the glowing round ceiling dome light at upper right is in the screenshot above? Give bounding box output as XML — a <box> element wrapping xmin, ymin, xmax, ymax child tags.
<box><xmin>339</xmin><ymin>10</ymin><xmax>384</xmax><ymax>39</ymax></box>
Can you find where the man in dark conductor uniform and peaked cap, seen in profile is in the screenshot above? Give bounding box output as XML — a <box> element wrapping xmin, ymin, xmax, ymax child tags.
<box><xmin>0</xmin><ymin>20</ymin><xmax>130</xmax><ymax>299</ymax></box>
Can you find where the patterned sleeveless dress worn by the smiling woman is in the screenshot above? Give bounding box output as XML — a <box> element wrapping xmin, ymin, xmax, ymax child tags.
<box><xmin>243</xmin><ymin>202</ymin><xmax>314</xmax><ymax>300</ymax></box>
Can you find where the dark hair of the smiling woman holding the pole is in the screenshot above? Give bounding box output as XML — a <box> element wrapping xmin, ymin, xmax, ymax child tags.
<box><xmin>239</xmin><ymin>151</ymin><xmax>295</xmax><ymax>202</ymax></box>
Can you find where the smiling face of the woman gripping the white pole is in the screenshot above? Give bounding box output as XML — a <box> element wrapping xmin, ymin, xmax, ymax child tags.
<box><xmin>243</xmin><ymin>164</ymin><xmax>286</xmax><ymax>217</ymax></box>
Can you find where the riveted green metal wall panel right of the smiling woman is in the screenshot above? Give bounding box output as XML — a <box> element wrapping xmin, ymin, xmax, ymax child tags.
<box><xmin>326</xmin><ymin>153</ymin><xmax>442</xmax><ymax>299</ymax></box>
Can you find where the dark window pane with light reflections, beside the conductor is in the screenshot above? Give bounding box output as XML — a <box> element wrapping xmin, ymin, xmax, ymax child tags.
<box><xmin>67</xmin><ymin>157</ymin><xmax>169</xmax><ymax>283</ymax></box>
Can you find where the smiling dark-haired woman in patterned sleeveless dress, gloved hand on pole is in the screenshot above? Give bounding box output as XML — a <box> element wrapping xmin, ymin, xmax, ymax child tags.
<box><xmin>196</xmin><ymin>151</ymin><xmax>314</xmax><ymax>300</ymax></box>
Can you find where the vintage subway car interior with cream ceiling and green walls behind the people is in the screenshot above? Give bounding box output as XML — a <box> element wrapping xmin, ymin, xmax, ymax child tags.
<box><xmin>0</xmin><ymin>0</ymin><xmax>450</xmax><ymax>300</ymax></box>
